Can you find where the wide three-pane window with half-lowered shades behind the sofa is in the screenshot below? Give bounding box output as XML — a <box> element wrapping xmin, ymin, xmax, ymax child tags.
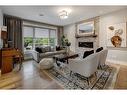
<box><xmin>23</xmin><ymin>26</ymin><xmax>57</xmax><ymax>50</ymax></box>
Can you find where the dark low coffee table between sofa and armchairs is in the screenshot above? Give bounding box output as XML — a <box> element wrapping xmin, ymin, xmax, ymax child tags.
<box><xmin>53</xmin><ymin>53</ymin><xmax>79</xmax><ymax>66</ymax></box>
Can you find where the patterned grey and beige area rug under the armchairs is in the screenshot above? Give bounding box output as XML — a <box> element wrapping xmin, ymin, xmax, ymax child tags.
<box><xmin>44</xmin><ymin>63</ymin><xmax>117</xmax><ymax>89</ymax></box>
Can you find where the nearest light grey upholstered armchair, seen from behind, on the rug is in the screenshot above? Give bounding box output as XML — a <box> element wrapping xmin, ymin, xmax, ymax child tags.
<box><xmin>68</xmin><ymin>53</ymin><xmax>100</xmax><ymax>85</ymax></box>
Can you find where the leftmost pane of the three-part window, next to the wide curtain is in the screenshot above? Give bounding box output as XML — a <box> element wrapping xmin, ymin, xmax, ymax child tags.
<box><xmin>23</xmin><ymin>27</ymin><xmax>33</xmax><ymax>50</ymax></box>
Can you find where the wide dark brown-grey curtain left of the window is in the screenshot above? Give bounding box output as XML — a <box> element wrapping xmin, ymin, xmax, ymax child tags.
<box><xmin>3</xmin><ymin>15</ymin><xmax>22</xmax><ymax>50</ymax></box>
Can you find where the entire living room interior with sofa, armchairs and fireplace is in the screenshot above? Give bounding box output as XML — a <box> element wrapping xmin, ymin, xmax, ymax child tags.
<box><xmin>0</xmin><ymin>5</ymin><xmax>127</xmax><ymax>89</ymax></box>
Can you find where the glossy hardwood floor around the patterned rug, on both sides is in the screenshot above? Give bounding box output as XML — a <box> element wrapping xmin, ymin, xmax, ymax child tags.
<box><xmin>0</xmin><ymin>61</ymin><xmax>127</xmax><ymax>89</ymax></box>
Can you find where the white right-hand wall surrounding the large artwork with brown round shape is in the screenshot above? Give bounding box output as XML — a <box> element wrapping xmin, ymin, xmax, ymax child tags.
<box><xmin>99</xmin><ymin>9</ymin><xmax>127</xmax><ymax>64</ymax></box>
